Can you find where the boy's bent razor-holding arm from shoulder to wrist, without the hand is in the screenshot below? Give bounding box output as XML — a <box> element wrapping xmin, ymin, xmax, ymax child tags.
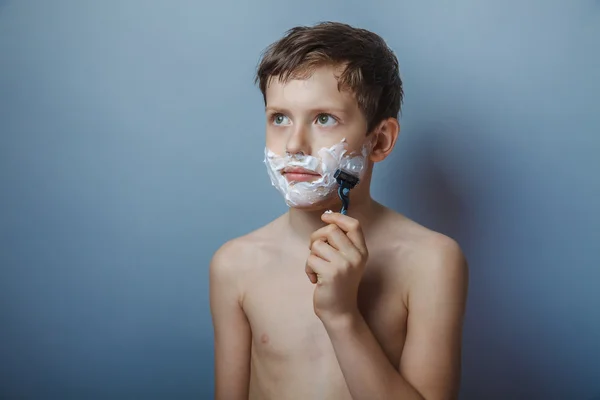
<box><xmin>324</xmin><ymin>233</ymin><xmax>468</xmax><ymax>400</ymax></box>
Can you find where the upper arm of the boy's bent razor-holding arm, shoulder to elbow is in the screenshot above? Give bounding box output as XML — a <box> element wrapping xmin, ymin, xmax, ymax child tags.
<box><xmin>400</xmin><ymin>236</ymin><xmax>468</xmax><ymax>399</ymax></box>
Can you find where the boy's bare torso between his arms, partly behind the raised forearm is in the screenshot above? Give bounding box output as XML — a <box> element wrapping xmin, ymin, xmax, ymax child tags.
<box><xmin>237</xmin><ymin>205</ymin><xmax>419</xmax><ymax>400</ymax></box>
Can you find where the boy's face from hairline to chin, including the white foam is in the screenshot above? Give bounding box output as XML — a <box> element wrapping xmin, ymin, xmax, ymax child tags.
<box><xmin>265</xmin><ymin>66</ymin><xmax>372</xmax><ymax>208</ymax></box>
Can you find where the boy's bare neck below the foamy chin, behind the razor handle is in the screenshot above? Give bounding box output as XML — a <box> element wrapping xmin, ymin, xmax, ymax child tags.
<box><xmin>287</xmin><ymin>193</ymin><xmax>379</xmax><ymax>245</ymax></box>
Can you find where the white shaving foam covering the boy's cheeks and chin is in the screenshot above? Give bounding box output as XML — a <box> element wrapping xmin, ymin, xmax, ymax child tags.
<box><xmin>264</xmin><ymin>138</ymin><xmax>371</xmax><ymax>207</ymax></box>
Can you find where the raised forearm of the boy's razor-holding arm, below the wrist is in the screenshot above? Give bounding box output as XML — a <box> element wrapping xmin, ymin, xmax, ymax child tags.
<box><xmin>323</xmin><ymin>312</ymin><xmax>424</xmax><ymax>400</ymax></box>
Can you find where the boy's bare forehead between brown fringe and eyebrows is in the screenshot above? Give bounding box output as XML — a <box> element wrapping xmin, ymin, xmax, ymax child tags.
<box><xmin>265</xmin><ymin>66</ymin><xmax>358</xmax><ymax>111</ymax></box>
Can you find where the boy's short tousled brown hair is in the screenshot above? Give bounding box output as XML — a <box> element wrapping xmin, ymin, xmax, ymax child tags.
<box><xmin>255</xmin><ymin>22</ymin><xmax>404</xmax><ymax>133</ymax></box>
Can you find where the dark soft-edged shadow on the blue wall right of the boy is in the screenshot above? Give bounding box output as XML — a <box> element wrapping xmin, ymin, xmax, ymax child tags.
<box><xmin>386</xmin><ymin>126</ymin><xmax>547</xmax><ymax>400</ymax></box>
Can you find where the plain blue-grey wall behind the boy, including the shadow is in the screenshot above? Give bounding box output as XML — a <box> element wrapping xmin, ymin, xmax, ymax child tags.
<box><xmin>0</xmin><ymin>0</ymin><xmax>600</xmax><ymax>400</ymax></box>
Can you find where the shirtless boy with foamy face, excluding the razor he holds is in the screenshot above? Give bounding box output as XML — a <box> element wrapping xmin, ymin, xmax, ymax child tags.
<box><xmin>210</xmin><ymin>22</ymin><xmax>468</xmax><ymax>400</ymax></box>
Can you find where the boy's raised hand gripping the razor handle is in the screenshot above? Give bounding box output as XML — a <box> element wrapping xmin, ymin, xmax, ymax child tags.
<box><xmin>306</xmin><ymin>213</ymin><xmax>368</xmax><ymax>320</ymax></box>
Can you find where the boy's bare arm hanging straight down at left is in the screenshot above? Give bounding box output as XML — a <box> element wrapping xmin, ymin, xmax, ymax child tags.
<box><xmin>210</xmin><ymin>243</ymin><xmax>252</xmax><ymax>400</ymax></box>
